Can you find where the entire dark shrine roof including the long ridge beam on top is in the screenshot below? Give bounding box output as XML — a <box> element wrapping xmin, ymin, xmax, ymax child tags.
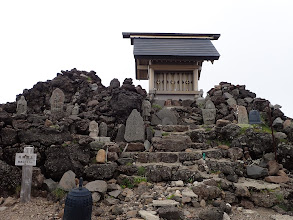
<box><xmin>123</xmin><ymin>33</ymin><xmax>220</xmax><ymax>60</ymax></box>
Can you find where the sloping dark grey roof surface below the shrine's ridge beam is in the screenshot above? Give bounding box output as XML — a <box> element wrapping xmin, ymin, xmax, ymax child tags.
<box><xmin>133</xmin><ymin>38</ymin><xmax>220</xmax><ymax>60</ymax></box>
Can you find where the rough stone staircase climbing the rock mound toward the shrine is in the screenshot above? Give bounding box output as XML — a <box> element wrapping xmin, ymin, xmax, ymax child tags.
<box><xmin>116</xmin><ymin>125</ymin><xmax>236</xmax><ymax>182</ymax></box>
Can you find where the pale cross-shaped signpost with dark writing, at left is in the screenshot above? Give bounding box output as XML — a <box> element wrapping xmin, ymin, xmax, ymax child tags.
<box><xmin>15</xmin><ymin>147</ymin><xmax>37</xmax><ymax>202</ymax></box>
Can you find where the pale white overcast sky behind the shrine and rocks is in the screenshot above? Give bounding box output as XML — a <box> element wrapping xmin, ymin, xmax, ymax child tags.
<box><xmin>0</xmin><ymin>0</ymin><xmax>293</xmax><ymax>117</ymax></box>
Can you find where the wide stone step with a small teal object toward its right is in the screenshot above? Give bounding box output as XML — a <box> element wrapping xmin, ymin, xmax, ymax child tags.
<box><xmin>122</xmin><ymin>148</ymin><xmax>227</xmax><ymax>163</ymax></box>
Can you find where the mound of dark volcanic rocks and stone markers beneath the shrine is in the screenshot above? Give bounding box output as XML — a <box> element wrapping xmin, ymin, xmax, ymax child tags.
<box><xmin>0</xmin><ymin>69</ymin><xmax>293</xmax><ymax>219</ymax></box>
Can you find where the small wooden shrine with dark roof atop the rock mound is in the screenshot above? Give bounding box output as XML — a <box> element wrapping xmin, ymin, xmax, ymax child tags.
<box><xmin>122</xmin><ymin>32</ymin><xmax>220</xmax><ymax>99</ymax></box>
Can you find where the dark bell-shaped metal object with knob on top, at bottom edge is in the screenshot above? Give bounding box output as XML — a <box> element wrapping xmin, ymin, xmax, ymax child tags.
<box><xmin>63</xmin><ymin>178</ymin><xmax>93</xmax><ymax>220</ymax></box>
